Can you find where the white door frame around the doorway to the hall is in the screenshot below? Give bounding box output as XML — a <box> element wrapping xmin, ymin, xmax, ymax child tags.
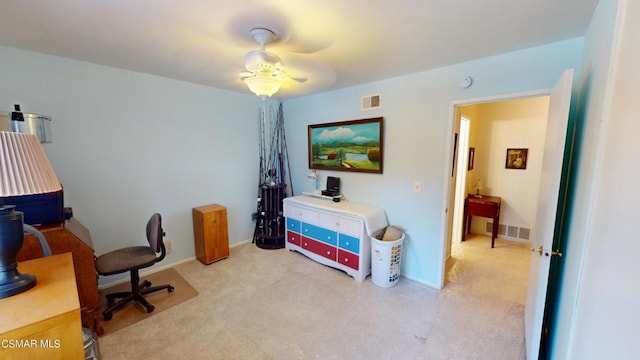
<box><xmin>436</xmin><ymin>88</ymin><xmax>553</xmax><ymax>289</ymax></box>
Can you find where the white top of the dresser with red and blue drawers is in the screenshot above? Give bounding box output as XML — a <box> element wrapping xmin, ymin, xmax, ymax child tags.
<box><xmin>283</xmin><ymin>195</ymin><xmax>388</xmax><ymax>235</ymax></box>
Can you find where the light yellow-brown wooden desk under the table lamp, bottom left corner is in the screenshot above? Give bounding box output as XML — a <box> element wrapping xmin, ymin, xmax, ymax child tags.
<box><xmin>0</xmin><ymin>253</ymin><xmax>84</xmax><ymax>360</ymax></box>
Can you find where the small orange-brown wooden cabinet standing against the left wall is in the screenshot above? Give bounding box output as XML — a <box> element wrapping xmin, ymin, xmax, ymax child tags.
<box><xmin>193</xmin><ymin>204</ymin><xmax>229</xmax><ymax>264</ymax></box>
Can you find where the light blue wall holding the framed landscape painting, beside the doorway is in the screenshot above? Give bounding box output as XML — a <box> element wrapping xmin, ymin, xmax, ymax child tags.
<box><xmin>284</xmin><ymin>38</ymin><xmax>583</xmax><ymax>287</ymax></box>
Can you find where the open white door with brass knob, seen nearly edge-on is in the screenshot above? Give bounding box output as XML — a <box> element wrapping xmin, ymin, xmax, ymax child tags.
<box><xmin>524</xmin><ymin>69</ymin><xmax>573</xmax><ymax>360</ymax></box>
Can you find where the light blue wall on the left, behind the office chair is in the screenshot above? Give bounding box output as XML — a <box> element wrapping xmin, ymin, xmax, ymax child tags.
<box><xmin>0</xmin><ymin>47</ymin><xmax>262</xmax><ymax>281</ymax></box>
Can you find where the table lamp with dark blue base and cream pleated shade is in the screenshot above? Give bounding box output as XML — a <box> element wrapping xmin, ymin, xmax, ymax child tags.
<box><xmin>0</xmin><ymin>131</ymin><xmax>62</xmax><ymax>299</ymax></box>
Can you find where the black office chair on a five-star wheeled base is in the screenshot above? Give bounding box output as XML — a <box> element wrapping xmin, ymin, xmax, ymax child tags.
<box><xmin>96</xmin><ymin>213</ymin><xmax>174</xmax><ymax>321</ymax></box>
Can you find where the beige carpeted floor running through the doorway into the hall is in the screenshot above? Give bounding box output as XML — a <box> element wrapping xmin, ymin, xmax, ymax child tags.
<box><xmin>99</xmin><ymin>236</ymin><xmax>531</xmax><ymax>360</ymax></box>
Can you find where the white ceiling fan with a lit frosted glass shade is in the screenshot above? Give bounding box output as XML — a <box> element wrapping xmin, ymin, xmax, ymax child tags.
<box><xmin>240</xmin><ymin>28</ymin><xmax>307</xmax><ymax>99</ymax></box>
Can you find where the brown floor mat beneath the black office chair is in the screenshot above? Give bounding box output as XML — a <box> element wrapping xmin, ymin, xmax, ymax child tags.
<box><xmin>100</xmin><ymin>268</ymin><xmax>198</xmax><ymax>336</ymax></box>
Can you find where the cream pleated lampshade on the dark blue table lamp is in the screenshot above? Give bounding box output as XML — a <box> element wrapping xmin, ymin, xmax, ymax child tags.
<box><xmin>0</xmin><ymin>131</ymin><xmax>62</xmax><ymax>197</ymax></box>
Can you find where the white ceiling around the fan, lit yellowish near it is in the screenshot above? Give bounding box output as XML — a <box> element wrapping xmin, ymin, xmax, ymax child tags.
<box><xmin>0</xmin><ymin>0</ymin><xmax>598</xmax><ymax>98</ymax></box>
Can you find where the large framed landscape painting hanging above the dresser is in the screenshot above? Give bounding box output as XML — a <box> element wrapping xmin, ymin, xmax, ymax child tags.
<box><xmin>308</xmin><ymin>117</ymin><xmax>384</xmax><ymax>174</ymax></box>
